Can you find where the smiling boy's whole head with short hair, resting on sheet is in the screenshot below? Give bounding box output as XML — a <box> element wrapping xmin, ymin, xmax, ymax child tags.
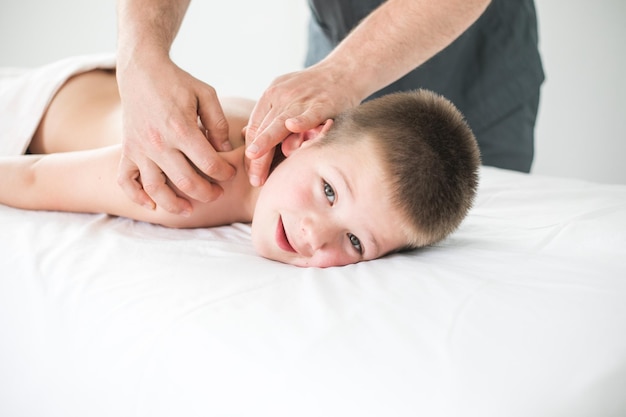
<box><xmin>252</xmin><ymin>90</ymin><xmax>480</xmax><ymax>267</ymax></box>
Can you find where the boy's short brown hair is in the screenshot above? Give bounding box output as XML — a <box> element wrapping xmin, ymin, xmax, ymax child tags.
<box><xmin>323</xmin><ymin>89</ymin><xmax>480</xmax><ymax>248</ymax></box>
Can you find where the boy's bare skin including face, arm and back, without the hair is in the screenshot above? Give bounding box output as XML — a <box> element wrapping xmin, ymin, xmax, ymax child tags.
<box><xmin>0</xmin><ymin>70</ymin><xmax>414</xmax><ymax>267</ymax></box>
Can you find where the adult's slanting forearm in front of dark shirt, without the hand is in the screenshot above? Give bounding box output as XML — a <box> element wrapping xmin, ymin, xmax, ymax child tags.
<box><xmin>318</xmin><ymin>0</ymin><xmax>490</xmax><ymax>99</ymax></box>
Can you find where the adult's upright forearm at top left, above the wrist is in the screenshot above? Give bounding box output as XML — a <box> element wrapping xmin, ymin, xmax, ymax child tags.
<box><xmin>117</xmin><ymin>0</ymin><xmax>190</xmax><ymax>66</ymax></box>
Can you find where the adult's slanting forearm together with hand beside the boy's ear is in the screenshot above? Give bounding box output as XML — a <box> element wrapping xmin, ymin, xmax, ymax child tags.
<box><xmin>241</xmin><ymin>0</ymin><xmax>490</xmax><ymax>185</ymax></box>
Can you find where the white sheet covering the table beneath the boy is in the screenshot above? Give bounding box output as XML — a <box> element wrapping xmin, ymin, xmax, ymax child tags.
<box><xmin>0</xmin><ymin>164</ymin><xmax>626</xmax><ymax>417</ymax></box>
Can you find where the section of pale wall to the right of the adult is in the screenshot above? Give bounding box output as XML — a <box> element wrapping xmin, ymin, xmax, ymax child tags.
<box><xmin>533</xmin><ymin>0</ymin><xmax>626</xmax><ymax>184</ymax></box>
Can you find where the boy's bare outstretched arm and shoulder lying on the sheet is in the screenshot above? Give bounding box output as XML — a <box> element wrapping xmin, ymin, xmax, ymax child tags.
<box><xmin>0</xmin><ymin>145</ymin><xmax>251</xmax><ymax>228</ymax></box>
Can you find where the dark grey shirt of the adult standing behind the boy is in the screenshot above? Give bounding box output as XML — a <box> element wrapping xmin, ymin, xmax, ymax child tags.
<box><xmin>306</xmin><ymin>0</ymin><xmax>544</xmax><ymax>136</ymax></box>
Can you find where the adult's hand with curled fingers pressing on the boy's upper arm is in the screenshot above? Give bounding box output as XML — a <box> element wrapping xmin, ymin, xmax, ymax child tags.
<box><xmin>117</xmin><ymin>53</ymin><xmax>235</xmax><ymax>215</ymax></box>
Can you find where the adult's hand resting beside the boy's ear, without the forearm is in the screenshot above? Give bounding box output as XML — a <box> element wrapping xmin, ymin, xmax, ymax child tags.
<box><xmin>246</xmin><ymin>64</ymin><xmax>363</xmax><ymax>186</ymax></box>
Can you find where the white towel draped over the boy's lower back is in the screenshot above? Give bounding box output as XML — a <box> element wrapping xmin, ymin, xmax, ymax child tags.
<box><xmin>0</xmin><ymin>54</ymin><xmax>115</xmax><ymax>156</ymax></box>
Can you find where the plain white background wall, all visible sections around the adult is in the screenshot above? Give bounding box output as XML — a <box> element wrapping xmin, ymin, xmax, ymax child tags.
<box><xmin>0</xmin><ymin>0</ymin><xmax>626</xmax><ymax>184</ymax></box>
